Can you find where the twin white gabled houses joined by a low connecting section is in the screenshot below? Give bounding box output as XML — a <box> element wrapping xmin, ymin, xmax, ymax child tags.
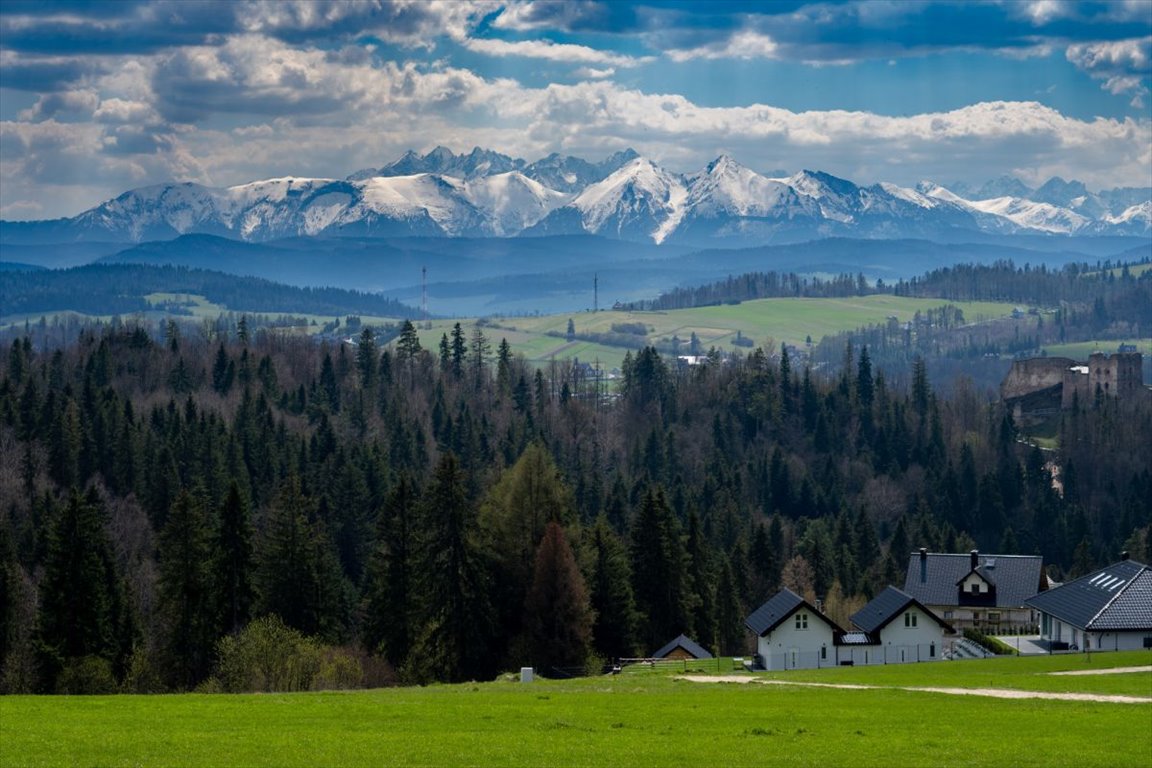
<box><xmin>744</xmin><ymin>587</ymin><xmax>952</xmax><ymax>669</ymax></box>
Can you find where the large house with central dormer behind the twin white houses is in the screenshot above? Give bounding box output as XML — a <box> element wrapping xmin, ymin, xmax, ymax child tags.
<box><xmin>904</xmin><ymin>549</ymin><xmax>1048</xmax><ymax>634</ymax></box>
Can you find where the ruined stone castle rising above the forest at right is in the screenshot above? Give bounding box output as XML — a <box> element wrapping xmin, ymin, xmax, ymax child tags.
<box><xmin>1000</xmin><ymin>352</ymin><xmax>1149</xmax><ymax>413</ymax></box>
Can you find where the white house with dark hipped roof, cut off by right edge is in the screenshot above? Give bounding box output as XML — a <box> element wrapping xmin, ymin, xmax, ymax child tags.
<box><xmin>1028</xmin><ymin>553</ymin><xmax>1152</xmax><ymax>651</ymax></box>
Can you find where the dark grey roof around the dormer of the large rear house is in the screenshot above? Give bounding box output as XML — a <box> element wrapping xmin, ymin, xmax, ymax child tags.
<box><xmin>904</xmin><ymin>552</ymin><xmax>1045</xmax><ymax>608</ymax></box>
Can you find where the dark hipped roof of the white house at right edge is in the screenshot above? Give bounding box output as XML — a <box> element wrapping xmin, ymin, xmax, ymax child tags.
<box><xmin>1028</xmin><ymin>560</ymin><xmax>1152</xmax><ymax>631</ymax></box>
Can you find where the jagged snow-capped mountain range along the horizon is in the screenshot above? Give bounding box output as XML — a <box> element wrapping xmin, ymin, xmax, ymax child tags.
<box><xmin>0</xmin><ymin>147</ymin><xmax>1152</xmax><ymax>246</ymax></box>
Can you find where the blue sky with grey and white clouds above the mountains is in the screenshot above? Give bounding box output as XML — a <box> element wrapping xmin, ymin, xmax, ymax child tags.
<box><xmin>0</xmin><ymin>0</ymin><xmax>1152</xmax><ymax>220</ymax></box>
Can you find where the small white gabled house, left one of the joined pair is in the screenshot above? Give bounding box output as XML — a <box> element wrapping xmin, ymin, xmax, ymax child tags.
<box><xmin>744</xmin><ymin>588</ymin><xmax>844</xmax><ymax>669</ymax></box>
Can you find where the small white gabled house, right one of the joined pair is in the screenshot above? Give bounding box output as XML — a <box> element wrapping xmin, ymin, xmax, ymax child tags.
<box><xmin>836</xmin><ymin>587</ymin><xmax>953</xmax><ymax>664</ymax></box>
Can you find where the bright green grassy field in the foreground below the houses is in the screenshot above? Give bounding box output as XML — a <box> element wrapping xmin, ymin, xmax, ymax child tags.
<box><xmin>0</xmin><ymin>653</ymin><xmax>1152</xmax><ymax>768</ymax></box>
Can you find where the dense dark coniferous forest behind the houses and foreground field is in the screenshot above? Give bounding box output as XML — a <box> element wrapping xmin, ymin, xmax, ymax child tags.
<box><xmin>0</xmin><ymin>308</ymin><xmax>1152</xmax><ymax>692</ymax></box>
